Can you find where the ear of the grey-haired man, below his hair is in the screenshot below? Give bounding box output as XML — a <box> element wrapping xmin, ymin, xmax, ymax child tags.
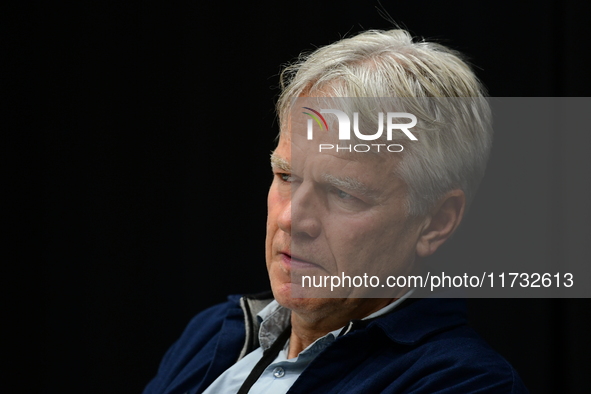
<box><xmin>417</xmin><ymin>189</ymin><xmax>466</xmax><ymax>257</ymax></box>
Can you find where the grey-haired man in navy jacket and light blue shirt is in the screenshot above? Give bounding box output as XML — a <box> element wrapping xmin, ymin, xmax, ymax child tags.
<box><xmin>145</xmin><ymin>30</ymin><xmax>526</xmax><ymax>394</ymax></box>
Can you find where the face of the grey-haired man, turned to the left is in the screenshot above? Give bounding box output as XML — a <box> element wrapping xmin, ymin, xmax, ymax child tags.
<box><xmin>266</xmin><ymin>107</ymin><xmax>420</xmax><ymax>313</ymax></box>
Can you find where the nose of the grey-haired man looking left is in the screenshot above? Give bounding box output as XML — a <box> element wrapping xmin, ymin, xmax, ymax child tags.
<box><xmin>279</xmin><ymin>184</ymin><xmax>322</xmax><ymax>238</ymax></box>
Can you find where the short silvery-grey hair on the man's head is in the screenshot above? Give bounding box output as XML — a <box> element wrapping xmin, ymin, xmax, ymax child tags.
<box><xmin>277</xmin><ymin>30</ymin><xmax>493</xmax><ymax>216</ymax></box>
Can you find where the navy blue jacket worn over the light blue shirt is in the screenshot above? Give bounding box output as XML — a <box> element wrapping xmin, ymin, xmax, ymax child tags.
<box><xmin>144</xmin><ymin>296</ymin><xmax>527</xmax><ymax>394</ymax></box>
